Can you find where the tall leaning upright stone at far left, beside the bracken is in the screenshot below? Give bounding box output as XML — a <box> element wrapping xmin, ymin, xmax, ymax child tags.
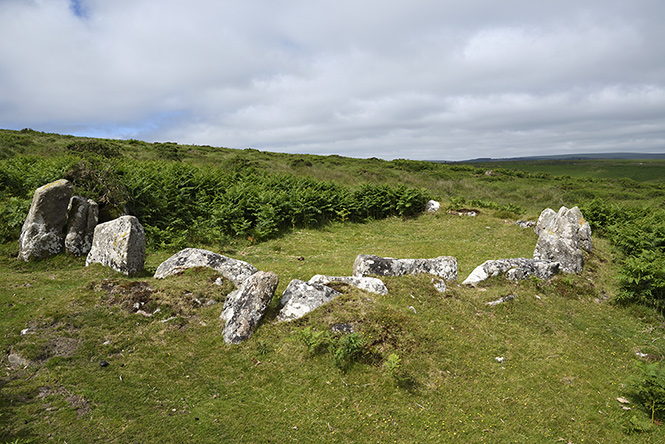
<box><xmin>18</xmin><ymin>179</ymin><xmax>74</xmax><ymax>261</ymax></box>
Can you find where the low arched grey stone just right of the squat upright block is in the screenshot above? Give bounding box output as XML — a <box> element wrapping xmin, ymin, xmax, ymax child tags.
<box><xmin>155</xmin><ymin>248</ymin><xmax>258</xmax><ymax>287</ymax></box>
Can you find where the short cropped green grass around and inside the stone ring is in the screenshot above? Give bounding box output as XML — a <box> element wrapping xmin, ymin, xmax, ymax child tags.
<box><xmin>0</xmin><ymin>214</ymin><xmax>665</xmax><ymax>443</ymax></box>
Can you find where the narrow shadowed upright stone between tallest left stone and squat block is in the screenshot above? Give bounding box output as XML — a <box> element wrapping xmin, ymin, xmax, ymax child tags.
<box><xmin>65</xmin><ymin>196</ymin><xmax>99</xmax><ymax>256</ymax></box>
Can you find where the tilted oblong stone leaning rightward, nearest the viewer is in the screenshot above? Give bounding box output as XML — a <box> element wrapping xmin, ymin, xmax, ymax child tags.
<box><xmin>221</xmin><ymin>271</ymin><xmax>279</xmax><ymax>344</ymax></box>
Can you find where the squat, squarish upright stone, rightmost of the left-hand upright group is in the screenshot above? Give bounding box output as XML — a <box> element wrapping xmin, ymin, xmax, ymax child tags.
<box><xmin>85</xmin><ymin>216</ymin><xmax>145</xmax><ymax>275</ymax></box>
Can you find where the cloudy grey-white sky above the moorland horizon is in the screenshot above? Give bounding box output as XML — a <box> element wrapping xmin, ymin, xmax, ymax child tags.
<box><xmin>0</xmin><ymin>0</ymin><xmax>665</xmax><ymax>160</ymax></box>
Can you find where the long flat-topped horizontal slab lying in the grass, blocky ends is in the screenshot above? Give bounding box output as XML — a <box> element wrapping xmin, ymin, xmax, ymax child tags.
<box><xmin>353</xmin><ymin>254</ymin><xmax>457</xmax><ymax>280</ymax></box>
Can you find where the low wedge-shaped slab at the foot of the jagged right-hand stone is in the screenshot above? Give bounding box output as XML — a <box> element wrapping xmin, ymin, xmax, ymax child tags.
<box><xmin>462</xmin><ymin>257</ymin><xmax>559</xmax><ymax>287</ymax></box>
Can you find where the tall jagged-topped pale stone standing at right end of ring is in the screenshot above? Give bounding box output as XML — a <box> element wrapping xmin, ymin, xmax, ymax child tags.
<box><xmin>533</xmin><ymin>207</ymin><xmax>593</xmax><ymax>273</ymax></box>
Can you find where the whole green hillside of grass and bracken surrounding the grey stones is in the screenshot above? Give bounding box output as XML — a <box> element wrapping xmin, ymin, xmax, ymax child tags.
<box><xmin>0</xmin><ymin>131</ymin><xmax>665</xmax><ymax>443</ymax></box>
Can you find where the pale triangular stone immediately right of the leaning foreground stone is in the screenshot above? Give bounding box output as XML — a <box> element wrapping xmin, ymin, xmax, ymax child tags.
<box><xmin>277</xmin><ymin>279</ymin><xmax>341</xmax><ymax>322</ymax></box>
